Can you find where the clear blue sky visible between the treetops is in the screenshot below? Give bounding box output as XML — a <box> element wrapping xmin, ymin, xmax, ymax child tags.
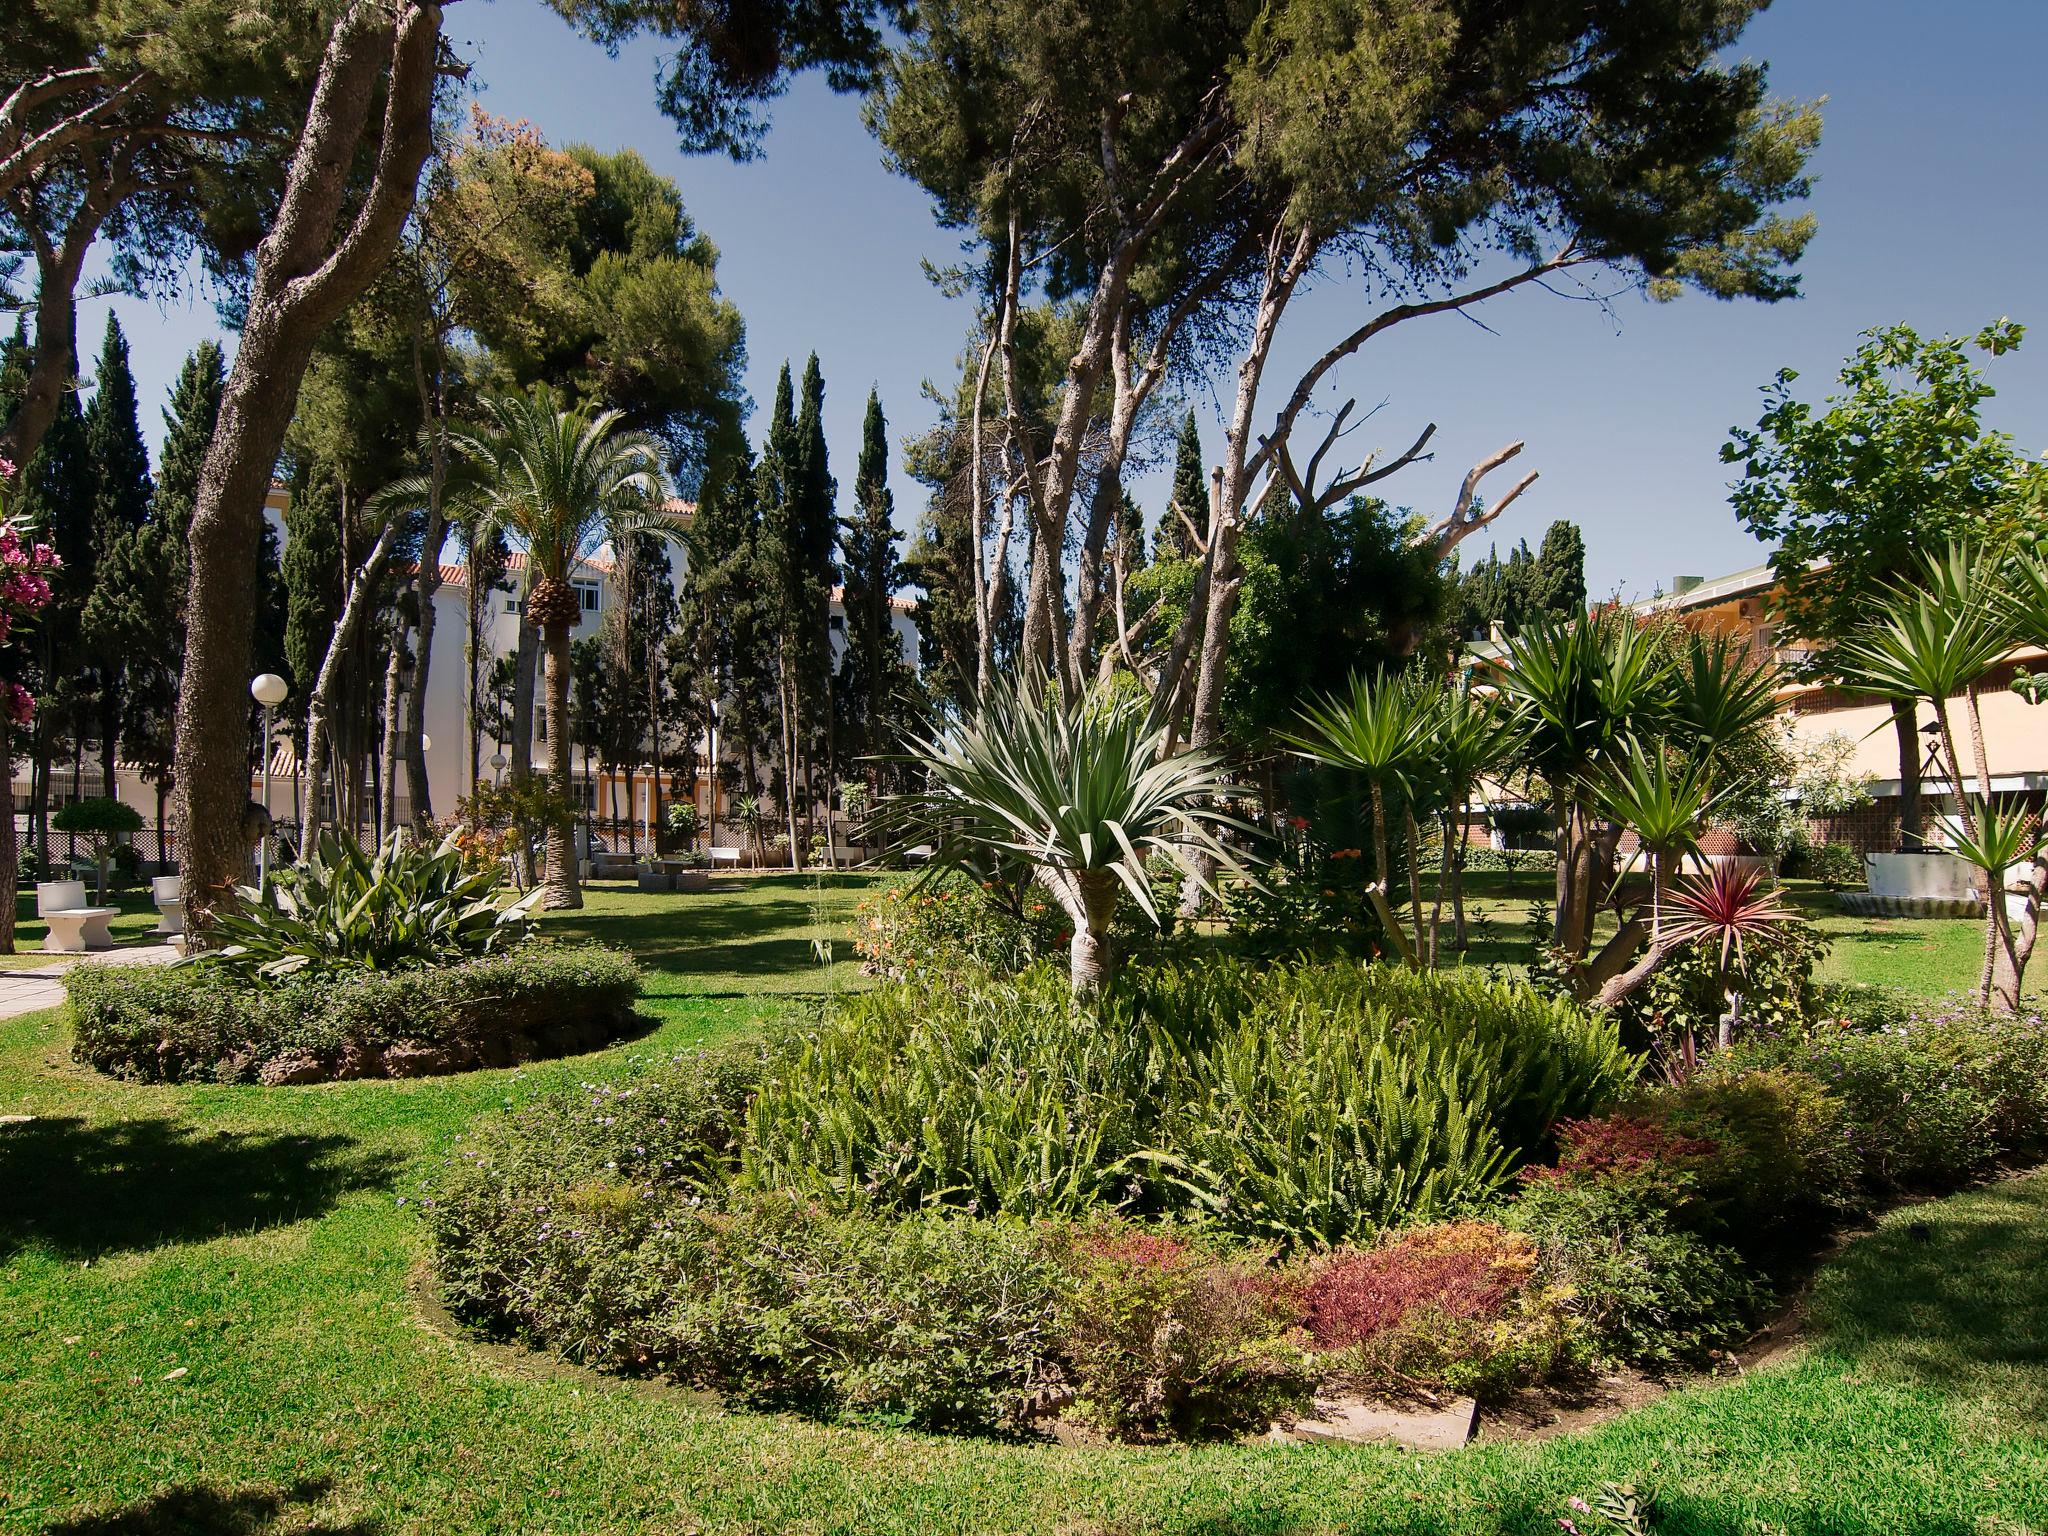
<box><xmin>80</xmin><ymin>0</ymin><xmax>2048</xmax><ymax>596</ymax></box>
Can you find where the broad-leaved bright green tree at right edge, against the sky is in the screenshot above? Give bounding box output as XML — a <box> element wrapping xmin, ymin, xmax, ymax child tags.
<box><xmin>1720</xmin><ymin>319</ymin><xmax>2048</xmax><ymax>844</ymax></box>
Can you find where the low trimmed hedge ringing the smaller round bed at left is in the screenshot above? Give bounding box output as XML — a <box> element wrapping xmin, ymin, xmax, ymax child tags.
<box><xmin>63</xmin><ymin>944</ymin><xmax>641</xmax><ymax>1083</ymax></box>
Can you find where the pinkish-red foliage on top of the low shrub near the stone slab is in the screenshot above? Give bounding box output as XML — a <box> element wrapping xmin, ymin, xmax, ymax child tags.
<box><xmin>1303</xmin><ymin>1221</ymin><xmax>1536</xmax><ymax>1350</ymax></box>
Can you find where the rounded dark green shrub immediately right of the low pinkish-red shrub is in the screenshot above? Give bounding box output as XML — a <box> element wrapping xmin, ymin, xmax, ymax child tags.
<box><xmin>1503</xmin><ymin>1182</ymin><xmax>1765</xmax><ymax>1368</ymax></box>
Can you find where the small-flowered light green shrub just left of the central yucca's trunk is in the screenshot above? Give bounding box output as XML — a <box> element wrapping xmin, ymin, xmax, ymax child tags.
<box><xmin>854</xmin><ymin>874</ymin><xmax>1065</xmax><ymax>981</ymax></box>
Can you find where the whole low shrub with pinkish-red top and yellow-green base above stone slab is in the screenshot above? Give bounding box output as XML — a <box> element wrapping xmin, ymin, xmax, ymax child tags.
<box><xmin>1303</xmin><ymin>1221</ymin><xmax>1573</xmax><ymax>1397</ymax></box>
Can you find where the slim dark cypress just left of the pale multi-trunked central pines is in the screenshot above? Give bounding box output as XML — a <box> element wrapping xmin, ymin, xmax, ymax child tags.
<box><xmin>840</xmin><ymin>389</ymin><xmax>903</xmax><ymax>756</ymax></box>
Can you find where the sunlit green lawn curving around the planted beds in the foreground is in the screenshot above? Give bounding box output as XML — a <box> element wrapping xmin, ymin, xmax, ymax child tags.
<box><xmin>0</xmin><ymin>877</ymin><xmax>2048</xmax><ymax>1536</ymax></box>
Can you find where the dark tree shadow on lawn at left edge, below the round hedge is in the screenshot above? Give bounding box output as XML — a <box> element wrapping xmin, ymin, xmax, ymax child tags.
<box><xmin>0</xmin><ymin>1118</ymin><xmax>397</xmax><ymax>1257</ymax></box>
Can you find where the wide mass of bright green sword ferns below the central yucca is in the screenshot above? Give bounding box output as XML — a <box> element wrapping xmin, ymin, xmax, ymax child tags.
<box><xmin>745</xmin><ymin>963</ymin><xmax>1634</xmax><ymax>1245</ymax></box>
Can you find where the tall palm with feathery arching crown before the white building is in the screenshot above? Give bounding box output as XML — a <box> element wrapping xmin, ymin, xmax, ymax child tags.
<box><xmin>449</xmin><ymin>385</ymin><xmax>680</xmax><ymax>907</ymax></box>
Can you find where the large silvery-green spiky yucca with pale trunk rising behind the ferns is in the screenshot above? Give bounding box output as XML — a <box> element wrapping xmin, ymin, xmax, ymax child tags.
<box><xmin>877</xmin><ymin>674</ymin><xmax>1251</xmax><ymax>995</ymax></box>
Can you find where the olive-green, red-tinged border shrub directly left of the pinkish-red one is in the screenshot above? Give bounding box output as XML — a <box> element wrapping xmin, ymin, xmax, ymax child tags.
<box><xmin>1059</xmin><ymin>1223</ymin><xmax>1313</xmax><ymax>1440</ymax></box>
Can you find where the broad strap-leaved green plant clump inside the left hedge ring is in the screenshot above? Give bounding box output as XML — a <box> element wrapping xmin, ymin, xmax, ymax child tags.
<box><xmin>190</xmin><ymin>829</ymin><xmax>541</xmax><ymax>981</ymax></box>
